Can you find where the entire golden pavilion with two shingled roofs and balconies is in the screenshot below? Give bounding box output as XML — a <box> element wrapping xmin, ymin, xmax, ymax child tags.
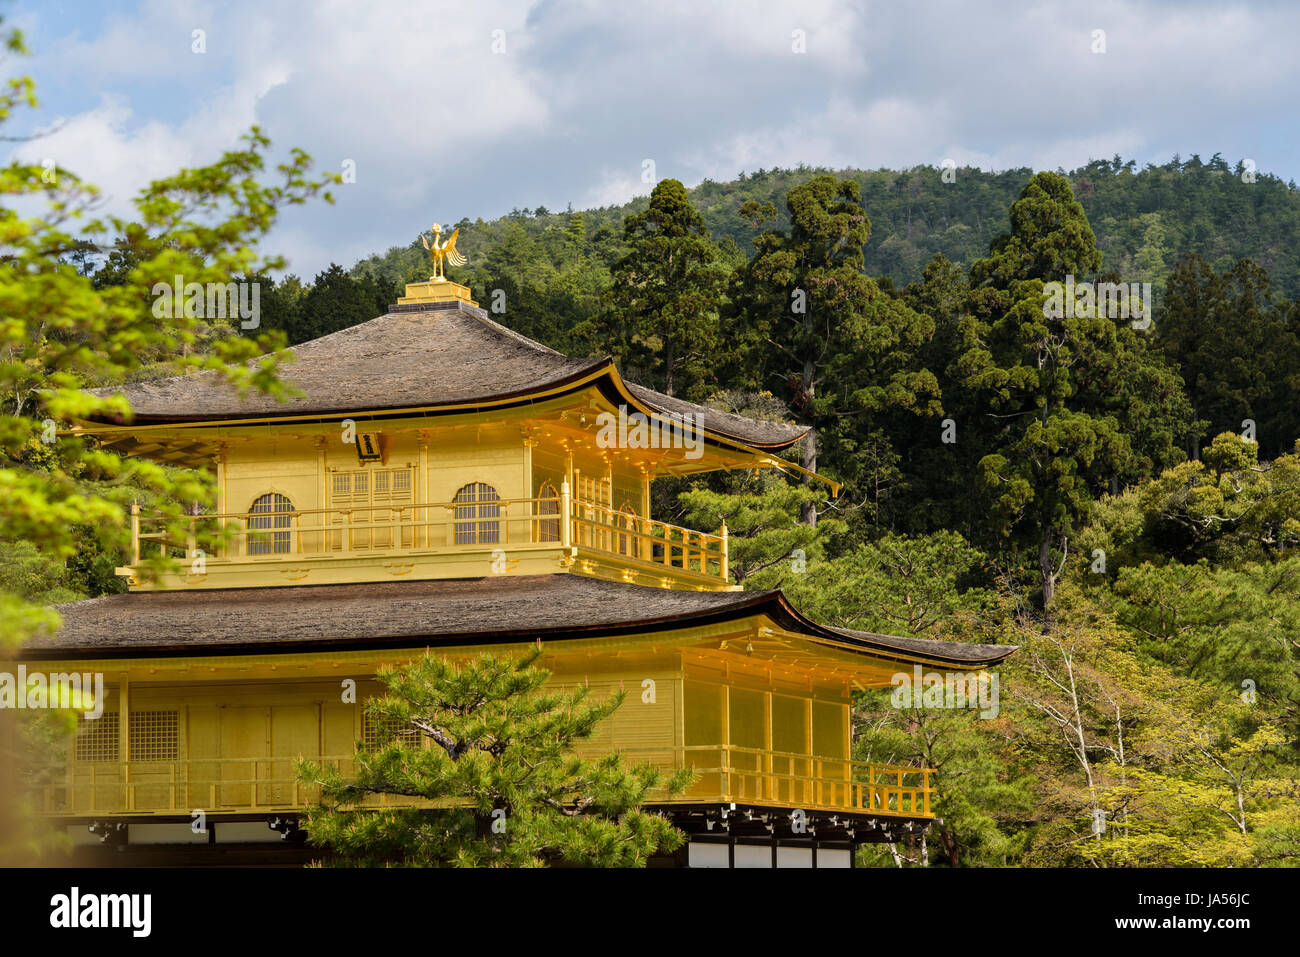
<box><xmin>22</xmin><ymin>280</ymin><xmax>1014</xmax><ymax>867</ymax></box>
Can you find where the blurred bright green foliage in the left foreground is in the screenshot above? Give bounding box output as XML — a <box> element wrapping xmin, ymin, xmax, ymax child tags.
<box><xmin>0</xmin><ymin>22</ymin><xmax>338</xmax><ymax>861</ymax></box>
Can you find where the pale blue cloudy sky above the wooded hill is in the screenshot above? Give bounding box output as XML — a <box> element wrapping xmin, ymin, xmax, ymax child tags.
<box><xmin>10</xmin><ymin>0</ymin><xmax>1300</xmax><ymax>277</ymax></box>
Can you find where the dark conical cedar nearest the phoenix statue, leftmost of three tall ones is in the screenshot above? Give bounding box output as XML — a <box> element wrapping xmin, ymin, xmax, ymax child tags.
<box><xmin>608</xmin><ymin>179</ymin><xmax>725</xmax><ymax>398</ymax></box>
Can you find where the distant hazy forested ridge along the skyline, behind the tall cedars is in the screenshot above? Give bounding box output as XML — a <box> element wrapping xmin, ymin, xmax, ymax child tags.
<box><xmin>345</xmin><ymin>153</ymin><xmax>1300</xmax><ymax>296</ymax></box>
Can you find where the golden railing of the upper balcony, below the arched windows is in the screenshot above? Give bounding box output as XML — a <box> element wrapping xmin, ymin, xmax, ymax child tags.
<box><xmin>131</xmin><ymin>490</ymin><xmax>728</xmax><ymax>581</ymax></box>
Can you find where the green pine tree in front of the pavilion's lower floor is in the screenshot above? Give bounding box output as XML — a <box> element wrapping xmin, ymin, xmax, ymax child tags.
<box><xmin>299</xmin><ymin>645</ymin><xmax>690</xmax><ymax>867</ymax></box>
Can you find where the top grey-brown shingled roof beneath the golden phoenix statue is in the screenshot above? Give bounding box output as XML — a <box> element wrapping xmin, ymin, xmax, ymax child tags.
<box><xmin>86</xmin><ymin>302</ymin><xmax>807</xmax><ymax>449</ymax></box>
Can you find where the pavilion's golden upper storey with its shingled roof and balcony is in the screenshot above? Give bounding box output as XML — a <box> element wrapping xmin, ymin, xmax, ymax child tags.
<box><xmin>77</xmin><ymin>281</ymin><xmax>832</xmax><ymax>590</ymax></box>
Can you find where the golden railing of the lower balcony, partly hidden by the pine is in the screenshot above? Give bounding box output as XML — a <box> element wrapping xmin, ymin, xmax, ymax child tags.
<box><xmin>36</xmin><ymin>745</ymin><xmax>933</xmax><ymax>818</ymax></box>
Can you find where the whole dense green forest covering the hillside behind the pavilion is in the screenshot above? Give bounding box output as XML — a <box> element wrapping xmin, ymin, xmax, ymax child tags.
<box><xmin>25</xmin><ymin>157</ymin><xmax>1300</xmax><ymax>866</ymax></box>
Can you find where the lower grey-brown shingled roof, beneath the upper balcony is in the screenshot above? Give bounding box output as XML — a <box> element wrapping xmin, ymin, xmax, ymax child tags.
<box><xmin>22</xmin><ymin>575</ymin><xmax>1015</xmax><ymax>666</ymax></box>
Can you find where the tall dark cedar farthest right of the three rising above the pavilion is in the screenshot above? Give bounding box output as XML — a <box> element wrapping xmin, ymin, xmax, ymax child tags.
<box><xmin>957</xmin><ymin>173</ymin><xmax>1130</xmax><ymax>607</ymax></box>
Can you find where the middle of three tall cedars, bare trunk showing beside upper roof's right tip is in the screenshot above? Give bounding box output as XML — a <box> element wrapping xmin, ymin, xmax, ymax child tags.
<box><xmin>737</xmin><ymin>176</ymin><xmax>939</xmax><ymax>524</ymax></box>
